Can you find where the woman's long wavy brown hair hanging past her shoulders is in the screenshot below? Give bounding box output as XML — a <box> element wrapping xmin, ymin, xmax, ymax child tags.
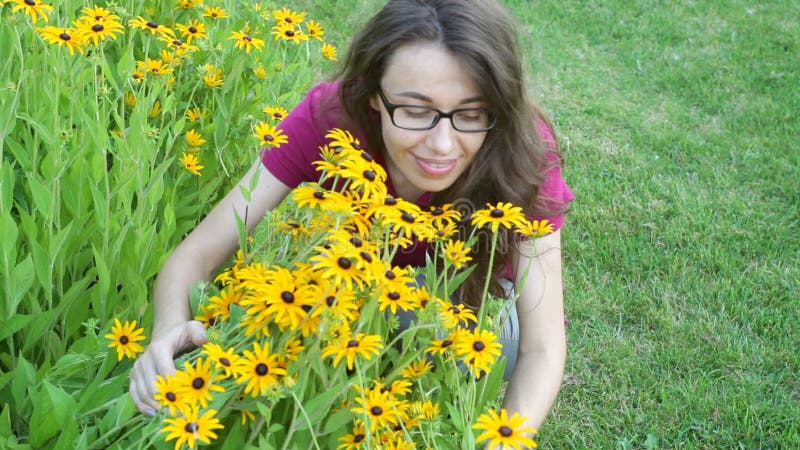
<box><xmin>338</xmin><ymin>0</ymin><xmax>555</xmax><ymax>308</ymax></box>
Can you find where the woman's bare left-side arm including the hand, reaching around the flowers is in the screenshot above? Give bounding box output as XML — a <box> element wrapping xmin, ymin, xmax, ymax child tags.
<box><xmin>130</xmin><ymin>159</ymin><xmax>290</xmax><ymax>414</ymax></box>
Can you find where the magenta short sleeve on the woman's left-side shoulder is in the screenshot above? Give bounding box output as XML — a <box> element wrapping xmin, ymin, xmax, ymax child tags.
<box><xmin>261</xmin><ymin>83</ymin><xmax>338</xmax><ymax>188</ymax></box>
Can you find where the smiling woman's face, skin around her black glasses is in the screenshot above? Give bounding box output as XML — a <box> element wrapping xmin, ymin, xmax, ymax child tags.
<box><xmin>370</xmin><ymin>42</ymin><xmax>489</xmax><ymax>201</ymax></box>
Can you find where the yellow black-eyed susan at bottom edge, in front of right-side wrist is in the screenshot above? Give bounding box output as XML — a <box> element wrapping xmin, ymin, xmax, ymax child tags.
<box><xmin>472</xmin><ymin>409</ymin><xmax>538</xmax><ymax>450</ymax></box>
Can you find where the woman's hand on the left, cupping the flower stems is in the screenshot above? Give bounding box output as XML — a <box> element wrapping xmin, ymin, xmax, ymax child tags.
<box><xmin>130</xmin><ymin>320</ymin><xmax>208</xmax><ymax>416</ymax></box>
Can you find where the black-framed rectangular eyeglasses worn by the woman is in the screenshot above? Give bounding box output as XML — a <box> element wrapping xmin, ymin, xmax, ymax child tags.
<box><xmin>378</xmin><ymin>89</ymin><xmax>495</xmax><ymax>133</ymax></box>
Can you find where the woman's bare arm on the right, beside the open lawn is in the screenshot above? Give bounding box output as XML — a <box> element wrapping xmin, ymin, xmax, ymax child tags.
<box><xmin>503</xmin><ymin>231</ymin><xmax>567</xmax><ymax>429</ymax></box>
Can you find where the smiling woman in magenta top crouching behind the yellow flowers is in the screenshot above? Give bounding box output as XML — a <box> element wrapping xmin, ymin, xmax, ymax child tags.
<box><xmin>130</xmin><ymin>0</ymin><xmax>573</xmax><ymax>428</ymax></box>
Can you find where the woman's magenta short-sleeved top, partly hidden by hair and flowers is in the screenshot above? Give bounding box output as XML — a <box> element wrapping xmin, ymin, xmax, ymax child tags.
<box><xmin>261</xmin><ymin>82</ymin><xmax>575</xmax><ymax>279</ymax></box>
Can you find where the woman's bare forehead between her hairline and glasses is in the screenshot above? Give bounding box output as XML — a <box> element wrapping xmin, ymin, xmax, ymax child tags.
<box><xmin>380</xmin><ymin>42</ymin><xmax>481</xmax><ymax>103</ymax></box>
